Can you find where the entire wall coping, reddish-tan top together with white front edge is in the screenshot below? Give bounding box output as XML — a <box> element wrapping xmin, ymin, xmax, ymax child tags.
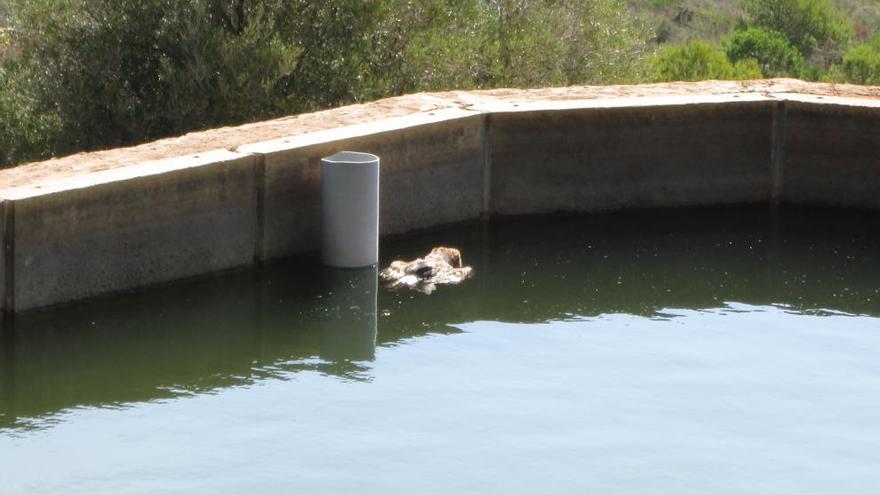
<box><xmin>0</xmin><ymin>79</ymin><xmax>880</xmax><ymax>200</ymax></box>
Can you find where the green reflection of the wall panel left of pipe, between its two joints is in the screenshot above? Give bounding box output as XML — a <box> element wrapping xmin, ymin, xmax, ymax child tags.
<box><xmin>4</xmin><ymin>272</ymin><xmax>259</xmax><ymax>428</ymax></box>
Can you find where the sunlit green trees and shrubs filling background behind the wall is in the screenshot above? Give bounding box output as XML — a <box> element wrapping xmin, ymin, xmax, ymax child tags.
<box><xmin>0</xmin><ymin>0</ymin><xmax>880</xmax><ymax>166</ymax></box>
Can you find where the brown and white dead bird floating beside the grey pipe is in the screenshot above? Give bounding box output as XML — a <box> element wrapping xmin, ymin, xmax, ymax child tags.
<box><xmin>379</xmin><ymin>246</ymin><xmax>473</xmax><ymax>294</ymax></box>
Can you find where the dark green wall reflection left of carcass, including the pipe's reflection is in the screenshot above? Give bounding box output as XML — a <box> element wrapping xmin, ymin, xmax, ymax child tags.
<box><xmin>0</xmin><ymin>260</ymin><xmax>377</xmax><ymax>428</ymax></box>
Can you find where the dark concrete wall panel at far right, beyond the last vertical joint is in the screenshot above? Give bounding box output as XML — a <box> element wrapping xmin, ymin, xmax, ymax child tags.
<box><xmin>780</xmin><ymin>101</ymin><xmax>880</xmax><ymax>208</ymax></box>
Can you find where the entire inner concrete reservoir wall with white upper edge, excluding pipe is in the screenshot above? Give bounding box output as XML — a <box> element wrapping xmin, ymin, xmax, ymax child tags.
<box><xmin>0</xmin><ymin>83</ymin><xmax>880</xmax><ymax>314</ymax></box>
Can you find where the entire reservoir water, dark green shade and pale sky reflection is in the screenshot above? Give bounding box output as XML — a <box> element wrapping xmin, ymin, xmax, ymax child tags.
<box><xmin>0</xmin><ymin>208</ymin><xmax>880</xmax><ymax>495</ymax></box>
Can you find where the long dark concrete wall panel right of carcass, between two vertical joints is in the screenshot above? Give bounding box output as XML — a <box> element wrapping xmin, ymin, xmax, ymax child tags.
<box><xmin>489</xmin><ymin>101</ymin><xmax>773</xmax><ymax>215</ymax></box>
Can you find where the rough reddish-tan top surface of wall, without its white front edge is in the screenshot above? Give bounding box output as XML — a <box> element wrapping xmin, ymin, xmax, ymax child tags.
<box><xmin>6</xmin><ymin>79</ymin><xmax>880</xmax><ymax>197</ymax></box>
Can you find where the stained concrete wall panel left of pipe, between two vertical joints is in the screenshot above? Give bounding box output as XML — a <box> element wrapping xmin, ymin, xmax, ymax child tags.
<box><xmin>7</xmin><ymin>152</ymin><xmax>256</xmax><ymax>311</ymax></box>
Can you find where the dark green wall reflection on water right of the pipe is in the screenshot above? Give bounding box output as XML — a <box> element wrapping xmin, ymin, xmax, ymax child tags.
<box><xmin>379</xmin><ymin>205</ymin><xmax>880</xmax><ymax>328</ymax></box>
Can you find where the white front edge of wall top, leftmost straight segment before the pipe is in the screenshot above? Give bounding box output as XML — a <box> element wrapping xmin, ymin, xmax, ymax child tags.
<box><xmin>0</xmin><ymin>149</ymin><xmax>251</xmax><ymax>201</ymax></box>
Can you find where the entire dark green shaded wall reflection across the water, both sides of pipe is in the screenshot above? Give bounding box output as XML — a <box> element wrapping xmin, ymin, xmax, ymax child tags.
<box><xmin>0</xmin><ymin>207</ymin><xmax>880</xmax><ymax>432</ymax></box>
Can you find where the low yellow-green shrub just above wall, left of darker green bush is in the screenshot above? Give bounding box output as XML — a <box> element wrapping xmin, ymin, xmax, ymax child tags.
<box><xmin>654</xmin><ymin>41</ymin><xmax>761</xmax><ymax>81</ymax></box>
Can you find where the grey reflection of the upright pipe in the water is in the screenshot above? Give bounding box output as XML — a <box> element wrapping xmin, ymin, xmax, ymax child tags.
<box><xmin>321</xmin><ymin>266</ymin><xmax>379</xmax><ymax>361</ymax></box>
